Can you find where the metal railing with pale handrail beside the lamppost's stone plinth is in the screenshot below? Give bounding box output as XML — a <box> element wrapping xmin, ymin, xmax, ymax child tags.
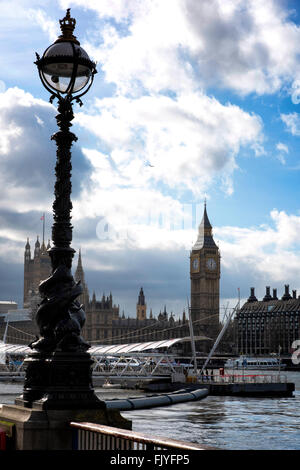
<box><xmin>70</xmin><ymin>422</ymin><xmax>212</xmax><ymax>451</ymax></box>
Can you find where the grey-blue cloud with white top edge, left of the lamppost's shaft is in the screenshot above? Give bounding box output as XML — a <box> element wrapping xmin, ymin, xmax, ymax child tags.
<box><xmin>0</xmin><ymin>87</ymin><xmax>91</xmax><ymax>212</ymax></box>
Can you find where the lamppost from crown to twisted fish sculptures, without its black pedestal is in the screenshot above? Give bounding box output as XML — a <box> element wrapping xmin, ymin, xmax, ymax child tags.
<box><xmin>31</xmin><ymin>9</ymin><xmax>96</xmax><ymax>351</ymax></box>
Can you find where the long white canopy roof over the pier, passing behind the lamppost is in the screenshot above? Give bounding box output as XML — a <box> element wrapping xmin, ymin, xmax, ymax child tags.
<box><xmin>0</xmin><ymin>336</ymin><xmax>210</xmax><ymax>356</ymax></box>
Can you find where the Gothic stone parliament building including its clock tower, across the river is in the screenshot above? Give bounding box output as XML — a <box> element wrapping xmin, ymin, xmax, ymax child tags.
<box><xmin>0</xmin><ymin>204</ymin><xmax>220</xmax><ymax>350</ymax></box>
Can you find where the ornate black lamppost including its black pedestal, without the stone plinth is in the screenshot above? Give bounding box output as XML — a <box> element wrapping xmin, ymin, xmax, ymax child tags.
<box><xmin>16</xmin><ymin>9</ymin><xmax>103</xmax><ymax>409</ymax></box>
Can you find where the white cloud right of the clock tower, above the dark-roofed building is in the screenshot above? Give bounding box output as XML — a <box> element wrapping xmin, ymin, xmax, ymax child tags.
<box><xmin>214</xmin><ymin>209</ymin><xmax>300</xmax><ymax>287</ymax></box>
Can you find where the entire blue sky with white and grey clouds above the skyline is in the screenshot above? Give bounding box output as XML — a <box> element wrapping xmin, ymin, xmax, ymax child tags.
<box><xmin>0</xmin><ymin>0</ymin><xmax>300</xmax><ymax>315</ymax></box>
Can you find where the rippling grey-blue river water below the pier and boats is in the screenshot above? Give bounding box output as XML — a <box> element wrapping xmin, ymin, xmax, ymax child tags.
<box><xmin>0</xmin><ymin>372</ymin><xmax>300</xmax><ymax>450</ymax></box>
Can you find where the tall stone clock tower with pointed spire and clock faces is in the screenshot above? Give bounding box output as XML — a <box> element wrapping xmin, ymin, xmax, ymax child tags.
<box><xmin>190</xmin><ymin>203</ymin><xmax>220</xmax><ymax>339</ymax></box>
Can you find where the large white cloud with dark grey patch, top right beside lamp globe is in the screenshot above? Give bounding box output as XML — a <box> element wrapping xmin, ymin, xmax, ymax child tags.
<box><xmin>60</xmin><ymin>0</ymin><xmax>300</xmax><ymax>94</ymax></box>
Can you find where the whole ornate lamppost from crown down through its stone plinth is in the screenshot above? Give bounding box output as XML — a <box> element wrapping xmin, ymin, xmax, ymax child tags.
<box><xmin>0</xmin><ymin>9</ymin><xmax>131</xmax><ymax>450</ymax></box>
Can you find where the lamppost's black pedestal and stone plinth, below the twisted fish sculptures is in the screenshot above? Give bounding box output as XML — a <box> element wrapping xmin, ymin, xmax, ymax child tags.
<box><xmin>0</xmin><ymin>351</ymin><xmax>132</xmax><ymax>450</ymax></box>
